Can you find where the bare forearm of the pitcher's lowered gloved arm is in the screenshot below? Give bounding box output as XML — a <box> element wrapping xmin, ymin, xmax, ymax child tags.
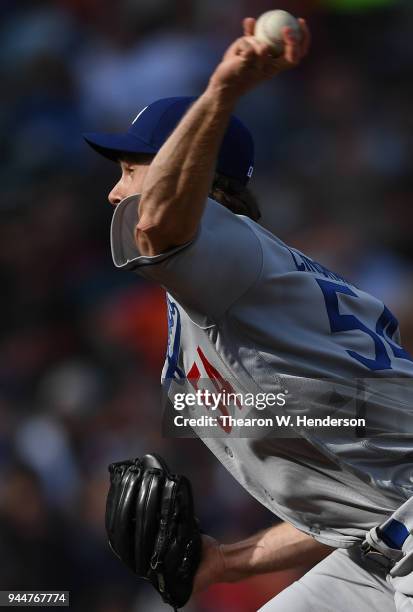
<box><xmin>220</xmin><ymin>523</ymin><xmax>333</xmax><ymax>582</ymax></box>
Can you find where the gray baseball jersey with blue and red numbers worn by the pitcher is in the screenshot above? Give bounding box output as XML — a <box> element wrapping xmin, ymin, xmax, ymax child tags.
<box><xmin>111</xmin><ymin>196</ymin><xmax>413</xmax><ymax>547</ymax></box>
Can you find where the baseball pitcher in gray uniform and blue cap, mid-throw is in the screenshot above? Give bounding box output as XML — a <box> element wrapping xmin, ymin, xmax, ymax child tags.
<box><xmin>85</xmin><ymin>18</ymin><xmax>413</xmax><ymax>612</ymax></box>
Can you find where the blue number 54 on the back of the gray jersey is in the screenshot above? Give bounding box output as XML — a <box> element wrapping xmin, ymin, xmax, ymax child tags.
<box><xmin>316</xmin><ymin>279</ymin><xmax>413</xmax><ymax>370</ymax></box>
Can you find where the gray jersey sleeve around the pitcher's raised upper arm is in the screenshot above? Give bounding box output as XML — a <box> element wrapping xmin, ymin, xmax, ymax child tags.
<box><xmin>111</xmin><ymin>196</ymin><xmax>262</xmax><ymax>318</ymax></box>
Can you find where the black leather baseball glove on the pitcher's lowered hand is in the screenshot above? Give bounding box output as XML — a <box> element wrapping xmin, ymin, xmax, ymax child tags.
<box><xmin>105</xmin><ymin>455</ymin><xmax>202</xmax><ymax>610</ymax></box>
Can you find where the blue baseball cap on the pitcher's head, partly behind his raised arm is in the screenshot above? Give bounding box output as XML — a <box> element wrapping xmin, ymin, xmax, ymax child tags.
<box><xmin>83</xmin><ymin>97</ymin><xmax>254</xmax><ymax>185</ymax></box>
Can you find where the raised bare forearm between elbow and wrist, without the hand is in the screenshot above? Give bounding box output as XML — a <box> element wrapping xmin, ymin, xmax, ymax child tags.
<box><xmin>137</xmin><ymin>85</ymin><xmax>235</xmax><ymax>254</ymax></box>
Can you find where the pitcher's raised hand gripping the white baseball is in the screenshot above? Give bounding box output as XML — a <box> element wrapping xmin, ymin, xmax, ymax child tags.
<box><xmin>210</xmin><ymin>17</ymin><xmax>310</xmax><ymax>97</ymax></box>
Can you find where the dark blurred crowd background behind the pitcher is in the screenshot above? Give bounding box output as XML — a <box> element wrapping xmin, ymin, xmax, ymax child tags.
<box><xmin>0</xmin><ymin>0</ymin><xmax>413</xmax><ymax>612</ymax></box>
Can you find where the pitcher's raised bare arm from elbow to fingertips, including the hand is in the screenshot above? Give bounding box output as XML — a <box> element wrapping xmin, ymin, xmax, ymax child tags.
<box><xmin>136</xmin><ymin>18</ymin><xmax>309</xmax><ymax>256</ymax></box>
